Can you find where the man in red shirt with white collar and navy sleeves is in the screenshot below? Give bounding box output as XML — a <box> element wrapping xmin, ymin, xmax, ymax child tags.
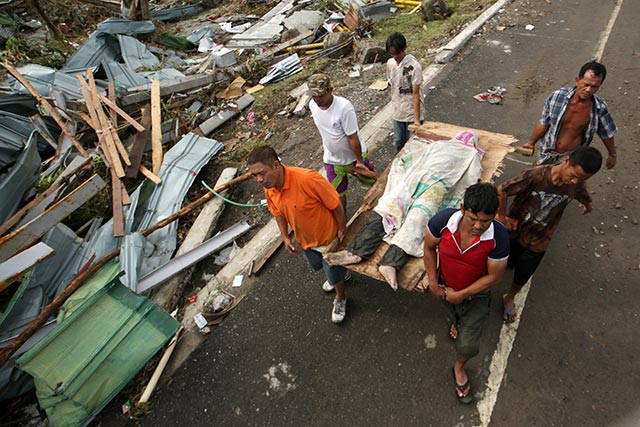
<box><xmin>424</xmin><ymin>184</ymin><xmax>509</xmax><ymax>403</ymax></box>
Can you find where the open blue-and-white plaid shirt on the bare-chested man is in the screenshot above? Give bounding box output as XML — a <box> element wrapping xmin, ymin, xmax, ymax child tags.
<box><xmin>538</xmin><ymin>87</ymin><xmax>618</xmax><ymax>163</ymax></box>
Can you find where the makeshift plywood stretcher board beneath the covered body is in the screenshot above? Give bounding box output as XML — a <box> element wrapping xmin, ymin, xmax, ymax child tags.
<box><xmin>329</xmin><ymin>122</ymin><xmax>517</xmax><ymax>292</ymax></box>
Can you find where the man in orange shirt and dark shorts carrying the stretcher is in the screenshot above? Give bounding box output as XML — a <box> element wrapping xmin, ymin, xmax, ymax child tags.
<box><xmin>247</xmin><ymin>146</ymin><xmax>347</xmax><ymax>323</ymax></box>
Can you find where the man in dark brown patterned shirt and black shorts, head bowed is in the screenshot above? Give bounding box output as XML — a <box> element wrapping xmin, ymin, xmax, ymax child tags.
<box><xmin>496</xmin><ymin>147</ymin><xmax>602</xmax><ymax>323</ymax></box>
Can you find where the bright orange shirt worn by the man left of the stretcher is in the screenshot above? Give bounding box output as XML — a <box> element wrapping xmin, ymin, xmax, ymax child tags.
<box><xmin>264</xmin><ymin>165</ymin><xmax>340</xmax><ymax>249</ymax></box>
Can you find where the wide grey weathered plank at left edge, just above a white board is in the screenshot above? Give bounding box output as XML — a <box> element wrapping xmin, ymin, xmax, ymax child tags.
<box><xmin>0</xmin><ymin>175</ymin><xmax>106</xmax><ymax>261</ymax></box>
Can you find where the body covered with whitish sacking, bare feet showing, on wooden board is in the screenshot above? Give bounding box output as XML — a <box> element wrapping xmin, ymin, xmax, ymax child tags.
<box><xmin>324</xmin><ymin>131</ymin><xmax>484</xmax><ymax>289</ymax></box>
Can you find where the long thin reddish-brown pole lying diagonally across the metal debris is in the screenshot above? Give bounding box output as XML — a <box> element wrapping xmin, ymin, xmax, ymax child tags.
<box><xmin>0</xmin><ymin>173</ymin><xmax>252</xmax><ymax>368</ymax></box>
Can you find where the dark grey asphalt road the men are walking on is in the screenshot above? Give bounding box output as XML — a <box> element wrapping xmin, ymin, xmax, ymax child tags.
<box><xmin>96</xmin><ymin>0</ymin><xmax>640</xmax><ymax>427</ymax></box>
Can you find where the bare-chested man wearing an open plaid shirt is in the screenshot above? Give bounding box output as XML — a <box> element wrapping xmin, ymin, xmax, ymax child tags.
<box><xmin>522</xmin><ymin>61</ymin><xmax>618</xmax><ymax>169</ymax></box>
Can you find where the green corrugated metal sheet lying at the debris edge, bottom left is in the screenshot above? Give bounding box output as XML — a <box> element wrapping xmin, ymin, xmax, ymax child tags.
<box><xmin>17</xmin><ymin>264</ymin><xmax>178</xmax><ymax>427</ymax></box>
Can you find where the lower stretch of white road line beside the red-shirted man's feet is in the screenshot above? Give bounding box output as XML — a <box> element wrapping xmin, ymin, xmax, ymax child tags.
<box><xmin>477</xmin><ymin>279</ymin><xmax>531</xmax><ymax>427</ymax></box>
